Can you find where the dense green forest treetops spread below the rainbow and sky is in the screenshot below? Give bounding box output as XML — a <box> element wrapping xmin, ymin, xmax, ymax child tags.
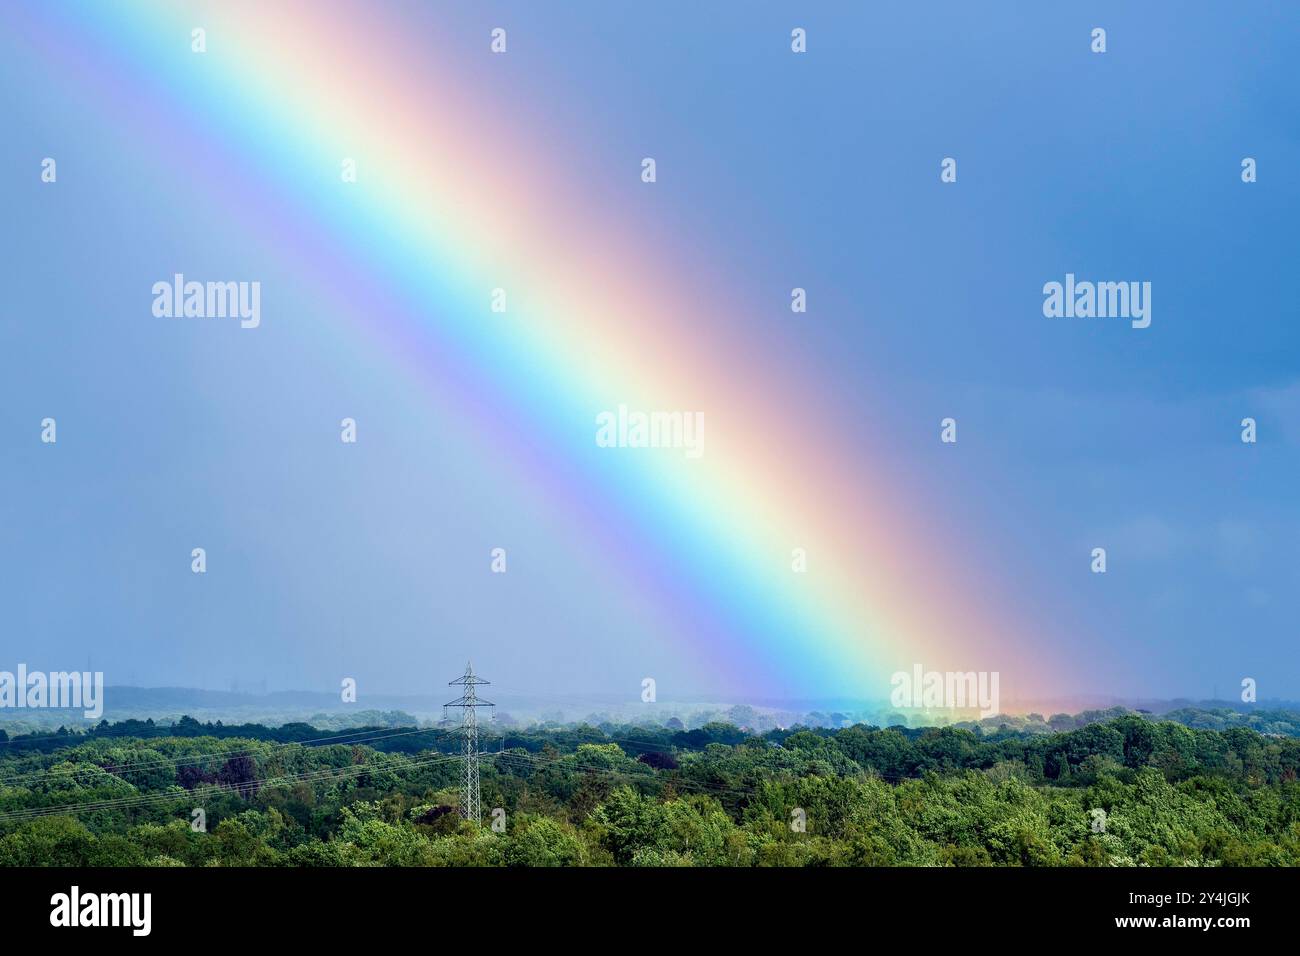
<box><xmin>0</xmin><ymin>713</ymin><xmax>1300</xmax><ymax>866</ymax></box>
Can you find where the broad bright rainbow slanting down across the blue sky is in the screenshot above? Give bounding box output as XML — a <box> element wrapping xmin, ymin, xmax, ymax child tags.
<box><xmin>7</xmin><ymin>0</ymin><xmax>1060</xmax><ymax>698</ymax></box>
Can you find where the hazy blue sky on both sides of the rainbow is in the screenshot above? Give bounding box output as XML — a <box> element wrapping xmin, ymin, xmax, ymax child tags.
<box><xmin>0</xmin><ymin>3</ymin><xmax>1300</xmax><ymax>697</ymax></box>
